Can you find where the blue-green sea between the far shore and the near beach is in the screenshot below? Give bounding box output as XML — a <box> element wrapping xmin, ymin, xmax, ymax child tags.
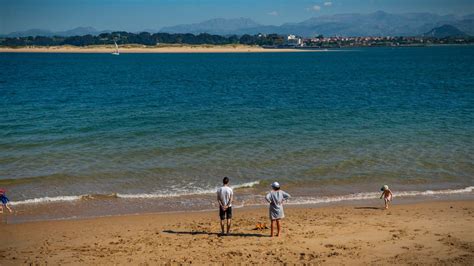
<box><xmin>0</xmin><ymin>46</ymin><xmax>474</xmax><ymax>223</ymax></box>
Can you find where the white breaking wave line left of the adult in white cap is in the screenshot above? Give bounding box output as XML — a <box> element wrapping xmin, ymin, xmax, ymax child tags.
<box><xmin>11</xmin><ymin>181</ymin><xmax>260</xmax><ymax>205</ymax></box>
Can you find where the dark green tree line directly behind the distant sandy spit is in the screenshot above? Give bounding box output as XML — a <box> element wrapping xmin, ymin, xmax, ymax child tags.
<box><xmin>0</xmin><ymin>31</ymin><xmax>284</xmax><ymax>47</ymax></box>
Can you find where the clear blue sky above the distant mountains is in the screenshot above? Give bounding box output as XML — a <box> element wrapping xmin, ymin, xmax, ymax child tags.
<box><xmin>0</xmin><ymin>0</ymin><xmax>474</xmax><ymax>34</ymax></box>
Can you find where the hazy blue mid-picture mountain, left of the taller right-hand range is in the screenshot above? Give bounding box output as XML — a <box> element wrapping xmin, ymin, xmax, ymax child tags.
<box><xmin>160</xmin><ymin>18</ymin><xmax>261</xmax><ymax>35</ymax></box>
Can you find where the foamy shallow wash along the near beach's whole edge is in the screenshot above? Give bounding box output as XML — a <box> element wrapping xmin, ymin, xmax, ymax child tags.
<box><xmin>4</xmin><ymin>186</ymin><xmax>474</xmax><ymax>224</ymax></box>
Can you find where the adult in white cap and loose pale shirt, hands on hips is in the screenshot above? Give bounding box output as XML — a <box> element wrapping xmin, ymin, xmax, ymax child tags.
<box><xmin>265</xmin><ymin>182</ymin><xmax>290</xmax><ymax>237</ymax></box>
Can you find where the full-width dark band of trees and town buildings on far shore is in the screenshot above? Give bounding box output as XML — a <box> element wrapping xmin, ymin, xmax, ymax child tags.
<box><xmin>0</xmin><ymin>32</ymin><xmax>474</xmax><ymax>49</ymax></box>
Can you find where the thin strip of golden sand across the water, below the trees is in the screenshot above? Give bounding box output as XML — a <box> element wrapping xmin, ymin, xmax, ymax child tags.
<box><xmin>0</xmin><ymin>45</ymin><xmax>321</xmax><ymax>53</ymax></box>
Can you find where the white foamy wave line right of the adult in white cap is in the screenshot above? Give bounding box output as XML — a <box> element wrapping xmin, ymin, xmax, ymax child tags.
<box><xmin>288</xmin><ymin>186</ymin><xmax>474</xmax><ymax>205</ymax></box>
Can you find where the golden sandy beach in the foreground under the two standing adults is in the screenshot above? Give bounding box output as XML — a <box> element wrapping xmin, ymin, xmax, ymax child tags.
<box><xmin>0</xmin><ymin>201</ymin><xmax>474</xmax><ymax>265</ymax></box>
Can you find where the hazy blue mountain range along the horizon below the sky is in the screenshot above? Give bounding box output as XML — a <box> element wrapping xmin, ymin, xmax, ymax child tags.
<box><xmin>2</xmin><ymin>11</ymin><xmax>474</xmax><ymax>37</ymax></box>
